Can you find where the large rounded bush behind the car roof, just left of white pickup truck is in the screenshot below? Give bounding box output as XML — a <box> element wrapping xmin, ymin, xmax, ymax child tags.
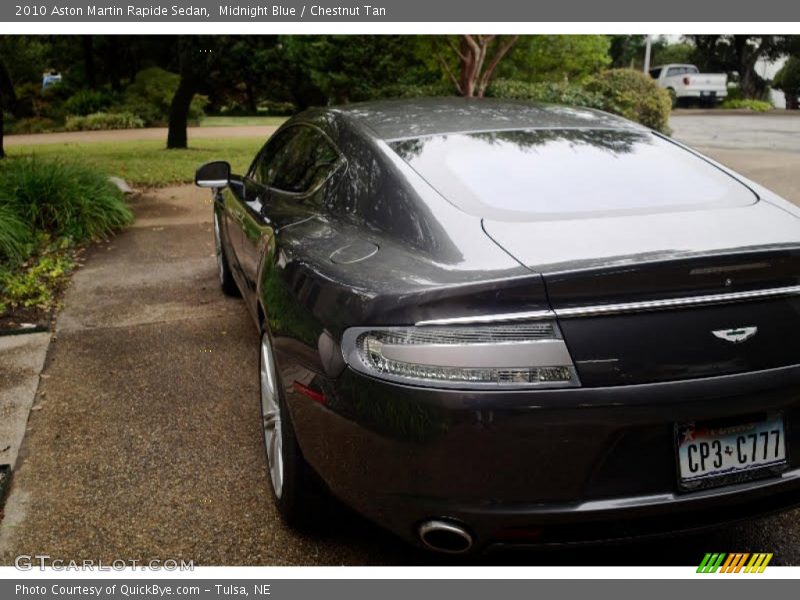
<box><xmin>586</xmin><ymin>69</ymin><xmax>672</xmax><ymax>132</ymax></box>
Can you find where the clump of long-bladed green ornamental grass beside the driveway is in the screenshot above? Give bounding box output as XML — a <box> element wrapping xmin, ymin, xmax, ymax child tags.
<box><xmin>0</xmin><ymin>157</ymin><xmax>133</xmax><ymax>241</ymax></box>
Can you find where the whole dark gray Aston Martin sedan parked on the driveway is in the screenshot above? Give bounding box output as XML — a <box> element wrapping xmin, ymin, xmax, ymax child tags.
<box><xmin>196</xmin><ymin>99</ymin><xmax>800</xmax><ymax>552</ymax></box>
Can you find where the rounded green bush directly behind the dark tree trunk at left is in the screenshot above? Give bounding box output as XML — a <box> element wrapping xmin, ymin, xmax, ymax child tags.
<box><xmin>115</xmin><ymin>67</ymin><xmax>208</xmax><ymax>126</ymax></box>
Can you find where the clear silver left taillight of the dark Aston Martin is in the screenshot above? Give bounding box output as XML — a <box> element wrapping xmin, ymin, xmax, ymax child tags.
<box><xmin>342</xmin><ymin>321</ymin><xmax>580</xmax><ymax>389</ymax></box>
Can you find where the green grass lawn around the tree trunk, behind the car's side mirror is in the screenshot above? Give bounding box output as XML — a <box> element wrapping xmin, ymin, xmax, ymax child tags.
<box><xmin>7</xmin><ymin>138</ymin><xmax>264</xmax><ymax>187</ymax></box>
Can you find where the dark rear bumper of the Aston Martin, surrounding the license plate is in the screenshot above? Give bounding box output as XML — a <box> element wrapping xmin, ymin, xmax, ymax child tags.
<box><xmin>285</xmin><ymin>358</ymin><xmax>800</xmax><ymax>546</ymax></box>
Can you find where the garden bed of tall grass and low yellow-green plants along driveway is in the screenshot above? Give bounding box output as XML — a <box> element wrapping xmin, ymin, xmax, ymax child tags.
<box><xmin>0</xmin><ymin>157</ymin><xmax>133</xmax><ymax>333</ymax></box>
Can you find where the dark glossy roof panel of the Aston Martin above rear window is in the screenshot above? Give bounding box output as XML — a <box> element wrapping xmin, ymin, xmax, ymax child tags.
<box><xmin>330</xmin><ymin>97</ymin><xmax>643</xmax><ymax>141</ymax></box>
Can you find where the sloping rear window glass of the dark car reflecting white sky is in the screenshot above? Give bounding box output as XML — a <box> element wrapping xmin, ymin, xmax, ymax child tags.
<box><xmin>390</xmin><ymin>129</ymin><xmax>757</xmax><ymax>218</ymax></box>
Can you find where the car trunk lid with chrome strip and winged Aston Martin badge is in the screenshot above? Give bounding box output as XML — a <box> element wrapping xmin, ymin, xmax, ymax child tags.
<box><xmin>484</xmin><ymin>201</ymin><xmax>800</xmax><ymax>386</ymax></box>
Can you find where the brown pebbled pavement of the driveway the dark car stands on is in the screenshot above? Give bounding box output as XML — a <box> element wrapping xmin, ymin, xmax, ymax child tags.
<box><xmin>0</xmin><ymin>116</ymin><xmax>800</xmax><ymax>565</ymax></box>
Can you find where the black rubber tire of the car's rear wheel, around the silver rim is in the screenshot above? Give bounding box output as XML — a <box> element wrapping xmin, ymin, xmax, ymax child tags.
<box><xmin>259</xmin><ymin>332</ymin><xmax>329</xmax><ymax>531</ymax></box>
